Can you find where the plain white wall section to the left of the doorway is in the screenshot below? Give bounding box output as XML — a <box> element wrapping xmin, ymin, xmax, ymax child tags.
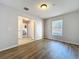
<box><xmin>0</xmin><ymin>4</ymin><xmax>18</xmax><ymax>50</ymax></box>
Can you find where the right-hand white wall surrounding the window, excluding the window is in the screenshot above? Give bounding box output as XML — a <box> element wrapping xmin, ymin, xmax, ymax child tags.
<box><xmin>44</xmin><ymin>11</ymin><xmax>79</xmax><ymax>45</ymax></box>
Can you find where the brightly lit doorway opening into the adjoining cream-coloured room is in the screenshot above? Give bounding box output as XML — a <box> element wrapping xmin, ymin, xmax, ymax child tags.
<box><xmin>18</xmin><ymin>16</ymin><xmax>35</xmax><ymax>45</ymax></box>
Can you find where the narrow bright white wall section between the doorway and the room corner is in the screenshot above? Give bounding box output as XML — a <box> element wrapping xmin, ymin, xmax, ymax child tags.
<box><xmin>35</xmin><ymin>18</ymin><xmax>44</xmax><ymax>40</ymax></box>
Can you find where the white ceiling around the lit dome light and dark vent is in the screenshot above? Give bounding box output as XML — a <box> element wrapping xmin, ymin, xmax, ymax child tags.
<box><xmin>0</xmin><ymin>0</ymin><xmax>79</xmax><ymax>18</ymax></box>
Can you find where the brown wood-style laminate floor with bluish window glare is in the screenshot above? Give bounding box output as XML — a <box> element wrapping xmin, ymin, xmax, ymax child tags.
<box><xmin>0</xmin><ymin>40</ymin><xmax>79</xmax><ymax>59</ymax></box>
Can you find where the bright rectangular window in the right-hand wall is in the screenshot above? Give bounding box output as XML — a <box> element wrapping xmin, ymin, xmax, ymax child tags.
<box><xmin>52</xmin><ymin>20</ymin><xmax>63</xmax><ymax>36</ymax></box>
